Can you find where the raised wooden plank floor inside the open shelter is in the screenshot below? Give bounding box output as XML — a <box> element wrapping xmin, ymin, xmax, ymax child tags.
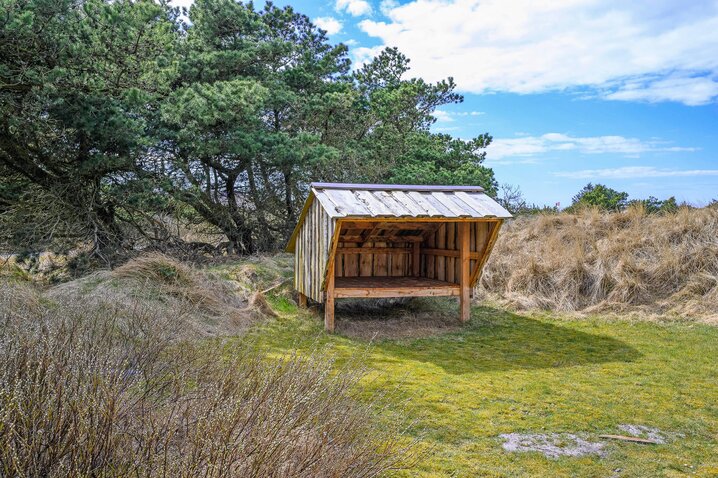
<box><xmin>334</xmin><ymin>277</ymin><xmax>459</xmax><ymax>298</ymax></box>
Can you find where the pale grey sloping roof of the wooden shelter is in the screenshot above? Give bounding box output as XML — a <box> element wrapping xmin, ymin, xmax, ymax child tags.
<box><xmin>312</xmin><ymin>183</ymin><xmax>511</xmax><ymax>222</ymax></box>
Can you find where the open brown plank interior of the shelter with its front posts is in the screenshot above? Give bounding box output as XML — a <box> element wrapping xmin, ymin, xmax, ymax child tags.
<box><xmin>310</xmin><ymin>218</ymin><xmax>502</xmax><ymax>330</ymax></box>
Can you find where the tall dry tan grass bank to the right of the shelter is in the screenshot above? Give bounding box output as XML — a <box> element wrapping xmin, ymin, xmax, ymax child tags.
<box><xmin>480</xmin><ymin>207</ymin><xmax>718</xmax><ymax>322</ymax></box>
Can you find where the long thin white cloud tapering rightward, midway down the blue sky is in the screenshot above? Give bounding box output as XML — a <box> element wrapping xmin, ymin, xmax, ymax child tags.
<box><xmin>486</xmin><ymin>133</ymin><xmax>696</xmax><ymax>161</ymax></box>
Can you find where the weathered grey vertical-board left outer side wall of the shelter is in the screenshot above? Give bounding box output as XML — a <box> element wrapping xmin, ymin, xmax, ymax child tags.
<box><xmin>294</xmin><ymin>200</ymin><xmax>336</xmax><ymax>302</ymax></box>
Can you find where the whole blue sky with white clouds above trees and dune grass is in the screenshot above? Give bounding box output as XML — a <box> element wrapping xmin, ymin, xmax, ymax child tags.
<box><xmin>177</xmin><ymin>0</ymin><xmax>718</xmax><ymax>206</ymax></box>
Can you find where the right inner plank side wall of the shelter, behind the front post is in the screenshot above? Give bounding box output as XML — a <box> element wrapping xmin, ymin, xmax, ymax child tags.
<box><xmin>421</xmin><ymin>222</ymin><xmax>496</xmax><ymax>284</ymax></box>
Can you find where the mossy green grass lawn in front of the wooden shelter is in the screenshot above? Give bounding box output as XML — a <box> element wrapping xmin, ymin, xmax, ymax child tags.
<box><xmin>252</xmin><ymin>299</ymin><xmax>718</xmax><ymax>477</ymax></box>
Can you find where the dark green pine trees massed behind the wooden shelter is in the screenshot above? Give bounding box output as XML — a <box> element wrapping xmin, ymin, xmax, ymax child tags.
<box><xmin>0</xmin><ymin>0</ymin><xmax>497</xmax><ymax>255</ymax></box>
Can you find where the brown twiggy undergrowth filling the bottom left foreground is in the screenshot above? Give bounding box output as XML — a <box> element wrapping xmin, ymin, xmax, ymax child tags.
<box><xmin>0</xmin><ymin>282</ymin><xmax>414</xmax><ymax>477</ymax></box>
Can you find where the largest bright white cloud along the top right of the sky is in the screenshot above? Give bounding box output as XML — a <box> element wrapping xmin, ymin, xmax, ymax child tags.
<box><xmin>362</xmin><ymin>0</ymin><xmax>718</xmax><ymax>105</ymax></box>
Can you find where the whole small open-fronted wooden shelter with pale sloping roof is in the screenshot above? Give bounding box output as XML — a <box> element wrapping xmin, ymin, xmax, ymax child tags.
<box><xmin>287</xmin><ymin>183</ymin><xmax>511</xmax><ymax>331</ymax></box>
